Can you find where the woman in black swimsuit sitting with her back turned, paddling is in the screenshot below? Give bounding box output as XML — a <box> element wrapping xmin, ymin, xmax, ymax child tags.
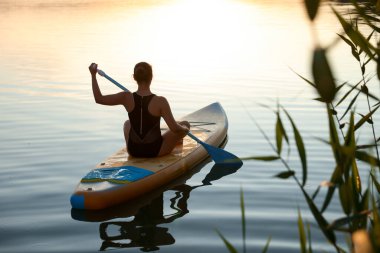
<box><xmin>89</xmin><ymin>62</ymin><xmax>190</xmax><ymax>157</ymax></box>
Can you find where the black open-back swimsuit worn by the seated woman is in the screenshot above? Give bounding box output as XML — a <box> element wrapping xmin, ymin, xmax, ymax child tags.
<box><xmin>128</xmin><ymin>92</ymin><xmax>162</xmax><ymax>157</ymax></box>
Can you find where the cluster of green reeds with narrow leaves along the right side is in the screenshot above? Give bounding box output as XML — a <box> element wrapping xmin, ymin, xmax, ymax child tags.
<box><xmin>218</xmin><ymin>0</ymin><xmax>380</xmax><ymax>253</ymax></box>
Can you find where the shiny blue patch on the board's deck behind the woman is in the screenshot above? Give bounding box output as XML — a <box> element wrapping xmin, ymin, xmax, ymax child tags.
<box><xmin>81</xmin><ymin>166</ymin><xmax>154</xmax><ymax>184</ymax></box>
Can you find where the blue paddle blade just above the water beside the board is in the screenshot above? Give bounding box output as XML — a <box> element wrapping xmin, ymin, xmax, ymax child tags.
<box><xmin>200</xmin><ymin>142</ymin><xmax>243</xmax><ymax>168</ymax></box>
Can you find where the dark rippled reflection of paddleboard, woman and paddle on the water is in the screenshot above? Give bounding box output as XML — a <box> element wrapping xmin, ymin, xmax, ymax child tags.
<box><xmin>71</xmin><ymin>164</ymin><xmax>241</xmax><ymax>252</ymax></box>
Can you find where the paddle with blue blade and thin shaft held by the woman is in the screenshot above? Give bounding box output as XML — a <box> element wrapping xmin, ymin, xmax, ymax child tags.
<box><xmin>98</xmin><ymin>69</ymin><xmax>243</xmax><ymax>167</ymax></box>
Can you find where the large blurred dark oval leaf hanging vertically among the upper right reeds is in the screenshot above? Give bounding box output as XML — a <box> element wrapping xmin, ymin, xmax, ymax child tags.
<box><xmin>312</xmin><ymin>48</ymin><xmax>336</xmax><ymax>103</ymax></box>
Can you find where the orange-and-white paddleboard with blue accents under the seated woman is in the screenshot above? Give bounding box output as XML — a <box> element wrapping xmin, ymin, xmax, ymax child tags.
<box><xmin>71</xmin><ymin>103</ymin><xmax>228</xmax><ymax>210</ymax></box>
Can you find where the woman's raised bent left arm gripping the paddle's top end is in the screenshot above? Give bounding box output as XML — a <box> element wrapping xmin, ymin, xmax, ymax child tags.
<box><xmin>89</xmin><ymin>63</ymin><xmax>128</xmax><ymax>106</ymax></box>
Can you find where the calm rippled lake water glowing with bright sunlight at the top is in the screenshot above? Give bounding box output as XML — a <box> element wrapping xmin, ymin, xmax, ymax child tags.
<box><xmin>0</xmin><ymin>0</ymin><xmax>375</xmax><ymax>252</ymax></box>
